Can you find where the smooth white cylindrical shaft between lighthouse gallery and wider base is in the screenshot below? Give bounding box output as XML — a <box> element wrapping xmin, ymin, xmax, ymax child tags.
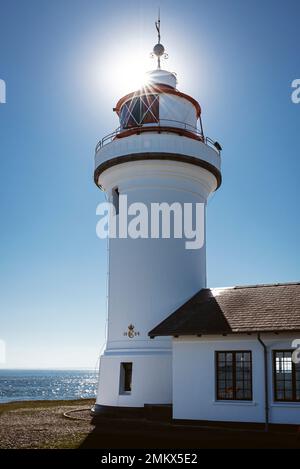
<box><xmin>102</xmin><ymin>160</ymin><xmax>215</xmax><ymax>348</ymax></box>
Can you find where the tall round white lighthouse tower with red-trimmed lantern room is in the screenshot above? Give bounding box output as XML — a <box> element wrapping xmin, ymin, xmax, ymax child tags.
<box><xmin>94</xmin><ymin>20</ymin><xmax>221</xmax><ymax>413</ymax></box>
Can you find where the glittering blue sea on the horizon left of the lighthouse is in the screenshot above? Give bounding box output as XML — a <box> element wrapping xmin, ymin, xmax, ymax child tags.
<box><xmin>0</xmin><ymin>369</ymin><xmax>98</xmax><ymax>403</ymax></box>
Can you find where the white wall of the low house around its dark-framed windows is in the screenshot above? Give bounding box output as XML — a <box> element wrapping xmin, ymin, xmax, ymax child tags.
<box><xmin>173</xmin><ymin>334</ymin><xmax>300</xmax><ymax>424</ymax></box>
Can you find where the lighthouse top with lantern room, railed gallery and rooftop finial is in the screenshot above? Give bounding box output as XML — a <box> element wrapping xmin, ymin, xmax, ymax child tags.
<box><xmin>94</xmin><ymin>12</ymin><xmax>221</xmax><ymax>188</ymax></box>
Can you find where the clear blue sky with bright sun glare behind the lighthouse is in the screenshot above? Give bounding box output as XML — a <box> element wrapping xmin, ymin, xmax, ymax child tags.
<box><xmin>0</xmin><ymin>0</ymin><xmax>300</xmax><ymax>368</ymax></box>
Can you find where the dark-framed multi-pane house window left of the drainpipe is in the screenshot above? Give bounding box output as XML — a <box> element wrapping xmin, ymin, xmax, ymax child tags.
<box><xmin>216</xmin><ymin>351</ymin><xmax>252</xmax><ymax>401</ymax></box>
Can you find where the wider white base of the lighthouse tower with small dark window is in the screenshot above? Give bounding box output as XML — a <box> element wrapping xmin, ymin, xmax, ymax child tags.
<box><xmin>94</xmin><ymin>349</ymin><xmax>172</xmax><ymax>413</ymax></box>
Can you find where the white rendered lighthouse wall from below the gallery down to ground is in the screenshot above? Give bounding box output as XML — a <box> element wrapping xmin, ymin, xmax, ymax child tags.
<box><xmin>97</xmin><ymin>157</ymin><xmax>216</xmax><ymax>407</ymax></box>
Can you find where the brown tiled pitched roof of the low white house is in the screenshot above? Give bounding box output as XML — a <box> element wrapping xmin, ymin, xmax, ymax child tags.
<box><xmin>149</xmin><ymin>283</ymin><xmax>300</xmax><ymax>337</ymax></box>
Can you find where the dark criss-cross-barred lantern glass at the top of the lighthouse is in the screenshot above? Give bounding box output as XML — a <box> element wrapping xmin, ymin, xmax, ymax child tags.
<box><xmin>120</xmin><ymin>94</ymin><xmax>159</xmax><ymax>129</ymax></box>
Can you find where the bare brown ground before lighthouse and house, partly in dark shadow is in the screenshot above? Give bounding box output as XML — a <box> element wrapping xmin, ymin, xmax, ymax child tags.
<box><xmin>0</xmin><ymin>400</ymin><xmax>300</xmax><ymax>449</ymax></box>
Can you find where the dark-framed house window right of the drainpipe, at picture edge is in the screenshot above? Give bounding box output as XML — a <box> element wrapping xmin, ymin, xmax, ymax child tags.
<box><xmin>273</xmin><ymin>350</ymin><xmax>300</xmax><ymax>402</ymax></box>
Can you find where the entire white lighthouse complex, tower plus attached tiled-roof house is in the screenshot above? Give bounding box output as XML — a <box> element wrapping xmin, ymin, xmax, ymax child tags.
<box><xmin>94</xmin><ymin>26</ymin><xmax>300</xmax><ymax>423</ymax></box>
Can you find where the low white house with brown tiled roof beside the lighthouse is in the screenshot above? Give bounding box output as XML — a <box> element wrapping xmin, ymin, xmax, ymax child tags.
<box><xmin>150</xmin><ymin>283</ymin><xmax>300</xmax><ymax>424</ymax></box>
